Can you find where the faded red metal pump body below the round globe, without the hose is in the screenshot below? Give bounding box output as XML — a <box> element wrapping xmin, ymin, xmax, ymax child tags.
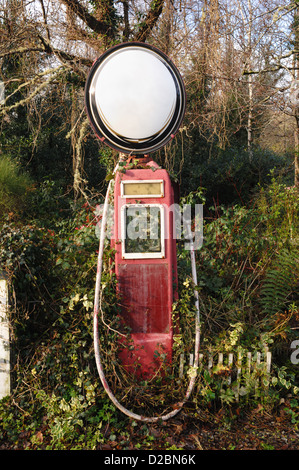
<box><xmin>114</xmin><ymin>159</ymin><xmax>177</xmax><ymax>378</ymax></box>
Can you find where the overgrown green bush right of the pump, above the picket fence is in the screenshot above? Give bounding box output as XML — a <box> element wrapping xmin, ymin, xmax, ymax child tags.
<box><xmin>197</xmin><ymin>174</ymin><xmax>299</xmax><ymax>334</ymax></box>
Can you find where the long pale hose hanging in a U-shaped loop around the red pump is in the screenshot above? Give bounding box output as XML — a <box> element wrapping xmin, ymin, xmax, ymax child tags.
<box><xmin>93</xmin><ymin>163</ymin><xmax>200</xmax><ymax>423</ymax></box>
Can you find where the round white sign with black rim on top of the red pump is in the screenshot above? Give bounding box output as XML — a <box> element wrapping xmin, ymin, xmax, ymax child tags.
<box><xmin>85</xmin><ymin>42</ymin><xmax>186</xmax><ymax>154</ymax></box>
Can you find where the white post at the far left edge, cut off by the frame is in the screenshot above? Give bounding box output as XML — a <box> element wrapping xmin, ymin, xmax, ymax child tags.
<box><xmin>0</xmin><ymin>273</ymin><xmax>10</xmax><ymax>399</ymax></box>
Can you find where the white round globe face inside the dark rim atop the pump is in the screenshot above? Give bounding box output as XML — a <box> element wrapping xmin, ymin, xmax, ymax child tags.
<box><xmin>94</xmin><ymin>49</ymin><xmax>176</xmax><ymax>140</ymax></box>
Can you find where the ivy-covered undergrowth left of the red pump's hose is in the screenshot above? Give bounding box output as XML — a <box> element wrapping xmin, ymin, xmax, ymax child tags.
<box><xmin>0</xmin><ymin>197</ymin><xmax>130</xmax><ymax>449</ymax></box>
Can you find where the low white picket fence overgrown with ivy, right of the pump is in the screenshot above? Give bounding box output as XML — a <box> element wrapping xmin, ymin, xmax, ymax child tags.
<box><xmin>179</xmin><ymin>345</ymin><xmax>272</xmax><ymax>401</ymax></box>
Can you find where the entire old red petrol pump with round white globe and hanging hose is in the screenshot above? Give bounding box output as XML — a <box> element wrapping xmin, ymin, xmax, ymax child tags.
<box><xmin>85</xmin><ymin>42</ymin><xmax>200</xmax><ymax>421</ymax></box>
